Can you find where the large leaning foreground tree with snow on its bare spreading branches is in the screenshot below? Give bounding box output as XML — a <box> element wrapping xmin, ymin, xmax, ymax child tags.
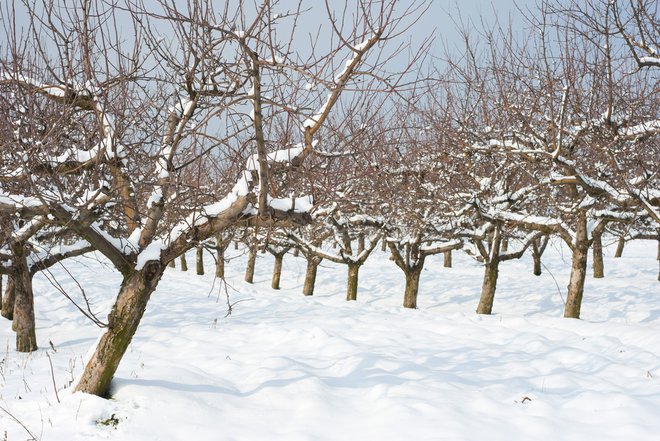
<box><xmin>1</xmin><ymin>0</ymin><xmax>428</xmax><ymax>396</ymax></box>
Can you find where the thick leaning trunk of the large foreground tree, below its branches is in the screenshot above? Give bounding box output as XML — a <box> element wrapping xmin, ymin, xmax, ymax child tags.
<box><xmin>75</xmin><ymin>261</ymin><xmax>164</xmax><ymax>397</ymax></box>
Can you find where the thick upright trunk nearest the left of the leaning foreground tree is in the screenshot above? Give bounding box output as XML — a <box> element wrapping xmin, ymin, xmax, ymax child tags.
<box><xmin>12</xmin><ymin>246</ymin><xmax>37</xmax><ymax>352</ymax></box>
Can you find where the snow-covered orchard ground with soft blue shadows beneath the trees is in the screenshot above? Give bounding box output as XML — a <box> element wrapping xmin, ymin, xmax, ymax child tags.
<box><xmin>0</xmin><ymin>241</ymin><xmax>660</xmax><ymax>441</ymax></box>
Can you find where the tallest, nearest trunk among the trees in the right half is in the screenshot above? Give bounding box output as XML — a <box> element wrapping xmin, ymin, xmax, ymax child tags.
<box><xmin>564</xmin><ymin>212</ymin><xmax>589</xmax><ymax>318</ymax></box>
